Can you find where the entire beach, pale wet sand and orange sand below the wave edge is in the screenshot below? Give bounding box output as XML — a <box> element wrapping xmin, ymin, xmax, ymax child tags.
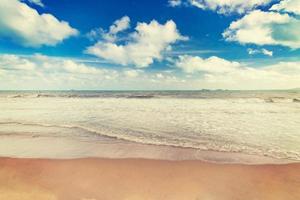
<box><xmin>0</xmin><ymin>119</ymin><xmax>300</xmax><ymax>200</ymax></box>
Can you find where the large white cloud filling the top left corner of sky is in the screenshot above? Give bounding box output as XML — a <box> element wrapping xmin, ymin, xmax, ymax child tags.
<box><xmin>0</xmin><ymin>0</ymin><xmax>78</xmax><ymax>47</ymax></box>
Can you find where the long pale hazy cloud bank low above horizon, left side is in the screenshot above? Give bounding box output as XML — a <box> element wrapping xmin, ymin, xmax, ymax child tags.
<box><xmin>0</xmin><ymin>54</ymin><xmax>185</xmax><ymax>90</ymax></box>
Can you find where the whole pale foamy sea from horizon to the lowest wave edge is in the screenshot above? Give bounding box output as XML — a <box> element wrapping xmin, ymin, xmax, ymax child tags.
<box><xmin>0</xmin><ymin>90</ymin><xmax>300</xmax><ymax>161</ymax></box>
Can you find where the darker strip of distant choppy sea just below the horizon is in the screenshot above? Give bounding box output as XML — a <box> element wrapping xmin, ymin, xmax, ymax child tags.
<box><xmin>0</xmin><ymin>90</ymin><xmax>300</xmax><ymax>103</ymax></box>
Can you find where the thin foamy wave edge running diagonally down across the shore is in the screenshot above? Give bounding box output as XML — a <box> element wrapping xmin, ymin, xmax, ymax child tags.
<box><xmin>0</xmin><ymin>121</ymin><xmax>300</xmax><ymax>161</ymax></box>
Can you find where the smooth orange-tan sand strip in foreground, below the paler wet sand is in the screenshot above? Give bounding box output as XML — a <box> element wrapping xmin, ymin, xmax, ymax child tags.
<box><xmin>0</xmin><ymin>158</ymin><xmax>300</xmax><ymax>200</ymax></box>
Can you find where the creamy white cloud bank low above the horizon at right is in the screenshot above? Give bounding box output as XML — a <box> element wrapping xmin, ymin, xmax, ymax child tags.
<box><xmin>176</xmin><ymin>56</ymin><xmax>300</xmax><ymax>89</ymax></box>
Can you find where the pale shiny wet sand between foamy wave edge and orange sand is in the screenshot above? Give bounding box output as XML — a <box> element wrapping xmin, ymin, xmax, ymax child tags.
<box><xmin>0</xmin><ymin>135</ymin><xmax>300</xmax><ymax>165</ymax></box>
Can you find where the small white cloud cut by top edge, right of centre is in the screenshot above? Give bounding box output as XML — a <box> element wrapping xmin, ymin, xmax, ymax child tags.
<box><xmin>189</xmin><ymin>0</ymin><xmax>272</xmax><ymax>14</ymax></box>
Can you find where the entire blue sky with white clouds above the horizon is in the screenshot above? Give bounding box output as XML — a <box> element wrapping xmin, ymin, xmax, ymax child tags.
<box><xmin>0</xmin><ymin>0</ymin><xmax>300</xmax><ymax>90</ymax></box>
